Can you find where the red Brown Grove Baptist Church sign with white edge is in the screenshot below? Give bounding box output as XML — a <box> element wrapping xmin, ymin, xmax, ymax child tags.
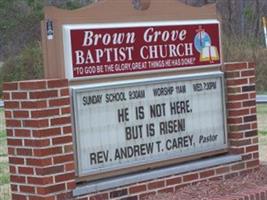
<box><xmin>63</xmin><ymin>20</ymin><xmax>222</xmax><ymax>79</ymax></box>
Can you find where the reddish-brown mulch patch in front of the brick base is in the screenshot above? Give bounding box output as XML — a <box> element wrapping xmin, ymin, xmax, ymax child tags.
<box><xmin>147</xmin><ymin>165</ymin><xmax>267</xmax><ymax>200</ymax></box>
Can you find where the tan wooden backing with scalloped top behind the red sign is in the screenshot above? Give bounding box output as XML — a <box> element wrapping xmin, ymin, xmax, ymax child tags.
<box><xmin>42</xmin><ymin>0</ymin><xmax>222</xmax><ymax>82</ymax></box>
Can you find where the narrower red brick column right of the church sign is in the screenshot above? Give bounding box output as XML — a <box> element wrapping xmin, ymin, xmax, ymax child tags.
<box><xmin>225</xmin><ymin>63</ymin><xmax>259</xmax><ymax>169</ymax></box>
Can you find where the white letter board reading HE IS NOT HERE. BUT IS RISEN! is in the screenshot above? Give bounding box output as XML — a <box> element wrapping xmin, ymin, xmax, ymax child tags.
<box><xmin>72</xmin><ymin>72</ymin><xmax>227</xmax><ymax>176</ymax></box>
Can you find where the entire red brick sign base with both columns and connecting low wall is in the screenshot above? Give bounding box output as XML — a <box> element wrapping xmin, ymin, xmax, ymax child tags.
<box><xmin>3</xmin><ymin>63</ymin><xmax>261</xmax><ymax>200</ymax></box>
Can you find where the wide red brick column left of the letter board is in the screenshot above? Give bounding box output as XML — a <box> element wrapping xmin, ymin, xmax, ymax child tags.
<box><xmin>3</xmin><ymin>80</ymin><xmax>75</xmax><ymax>200</ymax></box>
